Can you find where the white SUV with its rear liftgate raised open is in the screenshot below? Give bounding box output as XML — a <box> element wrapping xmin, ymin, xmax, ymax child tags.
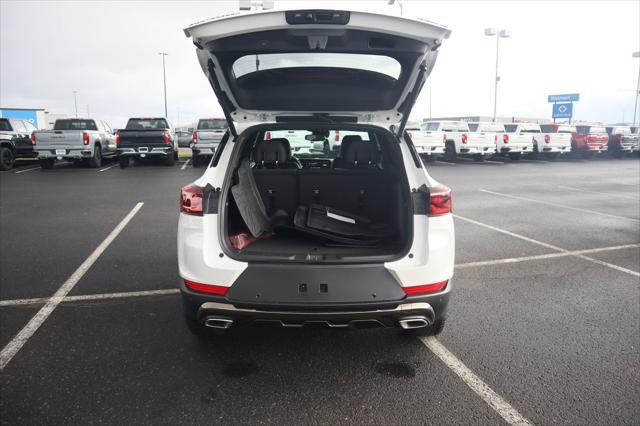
<box><xmin>178</xmin><ymin>10</ymin><xmax>454</xmax><ymax>334</ymax></box>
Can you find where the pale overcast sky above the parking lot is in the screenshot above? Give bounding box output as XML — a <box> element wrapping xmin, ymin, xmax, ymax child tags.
<box><xmin>0</xmin><ymin>0</ymin><xmax>640</xmax><ymax>127</ymax></box>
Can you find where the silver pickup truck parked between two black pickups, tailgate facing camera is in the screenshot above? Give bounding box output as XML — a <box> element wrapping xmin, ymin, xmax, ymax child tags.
<box><xmin>32</xmin><ymin>118</ymin><xmax>117</xmax><ymax>169</ymax></box>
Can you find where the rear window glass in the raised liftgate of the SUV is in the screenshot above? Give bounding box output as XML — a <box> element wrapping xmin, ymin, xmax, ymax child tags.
<box><xmin>232</xmin><ymin>52</ymin><xmax>401</xmax><ymax>80</ymax></box>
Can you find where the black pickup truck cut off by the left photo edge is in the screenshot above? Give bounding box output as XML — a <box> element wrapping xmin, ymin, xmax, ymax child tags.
<box><xmin>0</xmin><ymin>118</ymin><xmax>36</xmax><ymax>170</ymax></box>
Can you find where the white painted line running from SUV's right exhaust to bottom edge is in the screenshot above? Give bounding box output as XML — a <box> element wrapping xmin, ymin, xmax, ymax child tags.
<box><xmin>420</xmin><ymin>337</ymin><xmax>533</xmax><ymax>426</ymax></box>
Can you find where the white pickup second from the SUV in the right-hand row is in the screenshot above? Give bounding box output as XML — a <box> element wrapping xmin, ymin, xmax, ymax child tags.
<box><xmin>422</xmin><ymin>121</ymin><xmax>496</xmax><ymax>161</ymax></box>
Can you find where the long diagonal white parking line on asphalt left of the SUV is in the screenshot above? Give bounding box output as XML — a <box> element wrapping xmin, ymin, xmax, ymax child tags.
<box><xmin>0</xmin><ymin>203</ymin><xmax>144</xmax><ymax>371</ymax></box>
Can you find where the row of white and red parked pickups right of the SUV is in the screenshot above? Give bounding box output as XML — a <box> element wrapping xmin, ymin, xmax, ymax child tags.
<box><xmin>407</xmin><ymin>121</ymin><xmax>640</xmax><ymax>161</ymax></box>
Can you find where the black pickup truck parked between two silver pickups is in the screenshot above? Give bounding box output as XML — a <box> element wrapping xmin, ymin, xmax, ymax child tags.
<box><xmin>116</xmin><ymin>117</ymin><xmax>178</xmax><ymax>168</ymax></box>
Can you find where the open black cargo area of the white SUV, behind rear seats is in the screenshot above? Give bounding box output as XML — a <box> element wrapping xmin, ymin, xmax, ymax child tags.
<box><xmin>223</xmin><ymin>125</ymin><xmax>412</xmax><ymax>262</ymax></box>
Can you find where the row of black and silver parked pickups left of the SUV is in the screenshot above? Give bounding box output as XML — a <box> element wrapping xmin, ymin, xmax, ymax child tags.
<box><xmin>0</xmin><ymin>117</ymin><xmax>227</xmax><ymax>170</ymax></box>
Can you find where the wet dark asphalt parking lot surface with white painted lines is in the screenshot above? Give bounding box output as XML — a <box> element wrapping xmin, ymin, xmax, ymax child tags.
<box><xmin>0</xmin><ymin>158</ymin><xmax>640</xmax><ymax>424</ymax></box>
